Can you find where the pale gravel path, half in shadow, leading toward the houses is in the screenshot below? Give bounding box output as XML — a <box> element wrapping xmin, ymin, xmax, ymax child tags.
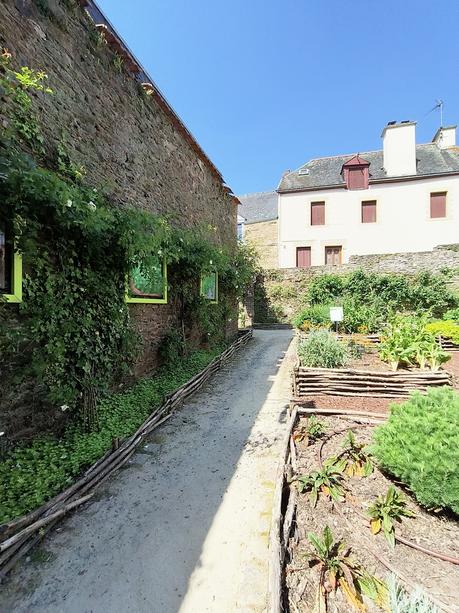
<box><xmin>0</xmin><ymin>330</ymin><xmax>294</xmax><ymax>613</ymax></box>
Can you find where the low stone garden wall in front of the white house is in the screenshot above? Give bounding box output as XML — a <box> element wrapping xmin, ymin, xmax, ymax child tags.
<box><xmin>254</xmin><ymin>245</ymin><xmax>459</xmax><ymax>323</ymax></box>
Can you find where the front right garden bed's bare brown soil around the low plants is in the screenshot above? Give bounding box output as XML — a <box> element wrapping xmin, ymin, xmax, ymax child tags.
<box><xmin>270</xmin><ymin>408</ymin><xmax>459</xmax><ymax>613</ymax></box>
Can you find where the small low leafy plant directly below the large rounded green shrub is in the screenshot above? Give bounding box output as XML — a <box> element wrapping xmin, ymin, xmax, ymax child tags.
<box><xmin>368</xmin><ymin>485</ymin><xmax>414</xmax><ymax>547</ymax></box>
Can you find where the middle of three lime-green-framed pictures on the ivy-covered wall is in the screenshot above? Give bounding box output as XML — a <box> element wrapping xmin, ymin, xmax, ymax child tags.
<box><xmin>126</xmin><ymin>258</ymin><xmax>167</xmax><ymax>304</ymax></box>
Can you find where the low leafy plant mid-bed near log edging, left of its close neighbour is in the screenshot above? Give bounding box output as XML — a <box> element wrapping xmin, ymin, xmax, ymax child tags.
<box><xmin>298</xmin><ymin>457</ymin><xmax>346</xmax><ymax>507</ymax></box>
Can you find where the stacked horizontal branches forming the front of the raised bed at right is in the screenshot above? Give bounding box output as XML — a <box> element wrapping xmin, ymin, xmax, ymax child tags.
<box><xmin>293</xmin><ymin>365</ymin><xmax>453</xmax><ymax>399</ymax></box>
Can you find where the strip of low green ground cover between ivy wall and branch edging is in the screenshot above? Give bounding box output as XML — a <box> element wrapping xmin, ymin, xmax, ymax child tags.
<box><xmin>0</xmin><ymin>348</ymin><xmax>221</xmax><ymax>523</ymax></box>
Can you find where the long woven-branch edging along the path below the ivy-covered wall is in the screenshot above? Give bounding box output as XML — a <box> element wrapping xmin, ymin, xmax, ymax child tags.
<box><xmin>0</xmin><ymin>329</ymin><xmax>253</xmax><ymax>581</ymax></box>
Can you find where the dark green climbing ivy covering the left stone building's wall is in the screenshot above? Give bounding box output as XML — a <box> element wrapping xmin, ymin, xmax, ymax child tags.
<box><xmin>0</xmin><ymin>51</ymin><xmax>255</xmax><ymax>429</ymax></box>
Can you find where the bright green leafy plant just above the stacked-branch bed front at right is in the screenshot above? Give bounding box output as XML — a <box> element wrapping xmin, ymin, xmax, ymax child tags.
<box><xmin>379</xmin><ymin>315</ymin><xmax>451</xmax><ymax>370</ymax></box>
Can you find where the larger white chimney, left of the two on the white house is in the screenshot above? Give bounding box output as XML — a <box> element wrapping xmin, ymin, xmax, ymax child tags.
<box><xmin>381</xmin><ymin>121</ymin><xmax>416</xmax><ymax>177</ymax></box>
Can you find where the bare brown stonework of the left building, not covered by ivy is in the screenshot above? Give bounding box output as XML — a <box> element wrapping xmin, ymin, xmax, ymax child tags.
<box><xmin>0</xmin><ymin>0</ymin><xmax>237</xmax><ymax>440</ymax></box>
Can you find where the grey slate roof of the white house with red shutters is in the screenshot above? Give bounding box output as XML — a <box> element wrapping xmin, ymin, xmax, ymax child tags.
<box><xmin>278</xmin><ymin>143</ymin><xmax>459</xmax><ymax>191</ymax></box>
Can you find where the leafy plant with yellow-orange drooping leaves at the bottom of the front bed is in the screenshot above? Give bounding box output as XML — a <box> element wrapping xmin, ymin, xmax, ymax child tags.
<box><xmin>307</xmin><ymin>526</ymin><xmax>387</xmax><ymax>611</ymax></box>
